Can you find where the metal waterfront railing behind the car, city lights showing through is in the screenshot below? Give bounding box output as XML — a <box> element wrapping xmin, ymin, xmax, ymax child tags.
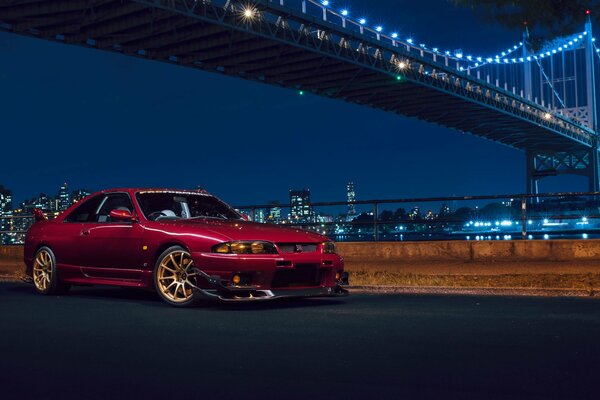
<box><xmin>0</xmin><ymin>192</ymin><xmax>600</xmax><ymax>245</ymax></box>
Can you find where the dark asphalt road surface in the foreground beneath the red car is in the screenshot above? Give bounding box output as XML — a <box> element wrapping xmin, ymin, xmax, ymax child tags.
<box><xmin>0</xmin><ymin>283</ymin><xmax>600</xmax><ymax>400</ymax></box>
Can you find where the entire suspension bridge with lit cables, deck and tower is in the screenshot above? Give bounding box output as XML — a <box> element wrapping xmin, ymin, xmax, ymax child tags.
<box><xmin>0</xmin><ymin>0</ymin><xmax>600</xmax><ymax>194</ymax></box>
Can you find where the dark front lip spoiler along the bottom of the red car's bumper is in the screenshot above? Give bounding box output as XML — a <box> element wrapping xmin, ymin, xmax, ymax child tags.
<box><xmin>192</xmin><ymin>268</ymin><xmax>348</xmax><ymax>302</ymax></box>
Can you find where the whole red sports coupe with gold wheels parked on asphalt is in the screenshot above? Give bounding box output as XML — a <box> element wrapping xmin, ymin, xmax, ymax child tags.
<box><xmin>24</xmin><ymin>189</ymin><xmax>348</xmax><ymax>306</ymax></box>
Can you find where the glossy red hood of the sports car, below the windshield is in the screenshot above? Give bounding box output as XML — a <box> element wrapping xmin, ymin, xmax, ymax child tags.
<box><xmin>152</xmin><ymin>219</ymin><xmax>329</xmax><ymax>243</ymax></box>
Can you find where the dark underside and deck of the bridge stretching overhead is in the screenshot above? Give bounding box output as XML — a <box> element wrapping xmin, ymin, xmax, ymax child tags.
<box><xmin>0</xmin><ymin>0</ymin><xmax>592</xmax><ymax>153</ymax></box>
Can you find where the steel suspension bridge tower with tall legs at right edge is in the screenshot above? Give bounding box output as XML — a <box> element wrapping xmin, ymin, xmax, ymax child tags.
<box><xmin>523</xmin><ymin>11</ymin><xmax>600</xmax><ymax>194</ymax></box>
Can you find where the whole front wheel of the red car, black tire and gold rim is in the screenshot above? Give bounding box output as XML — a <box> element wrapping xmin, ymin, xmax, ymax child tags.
<box><xmin>153</xmin><ymin>246</ymin><xmax>196</xmax><ymax>307</ymax></box>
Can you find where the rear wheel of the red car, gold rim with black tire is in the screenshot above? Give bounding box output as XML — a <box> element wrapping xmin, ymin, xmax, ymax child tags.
<box><xmin>32</xmin><ymin>246</ymin><xmax>71</xmax><ymax>295</ymax></box>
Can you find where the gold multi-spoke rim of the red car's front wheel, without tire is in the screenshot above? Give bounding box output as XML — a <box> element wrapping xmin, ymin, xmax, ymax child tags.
<box><xmin>157</xmin><ymin>250</ymin><xmax>197</xmax><ymax>303</ymax></box>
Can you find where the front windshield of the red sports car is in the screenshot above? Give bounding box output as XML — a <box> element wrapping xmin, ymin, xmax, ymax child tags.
<box><xmin>136</xmin><ymin>192</ymin><xmax>242</xmax><ymax>221</ymax></box>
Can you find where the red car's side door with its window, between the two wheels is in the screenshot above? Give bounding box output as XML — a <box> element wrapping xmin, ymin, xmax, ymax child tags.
<box><xmin>79</xmin><ymin>192</ymin><xmax>144</xmax><ymax>280</ymax></box>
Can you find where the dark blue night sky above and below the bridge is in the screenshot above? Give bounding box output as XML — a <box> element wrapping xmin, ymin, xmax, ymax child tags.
<box><xmin>0</xmin><ymin>0</ymin><xmax>587</xmax><ymax>204</ymax></box>
